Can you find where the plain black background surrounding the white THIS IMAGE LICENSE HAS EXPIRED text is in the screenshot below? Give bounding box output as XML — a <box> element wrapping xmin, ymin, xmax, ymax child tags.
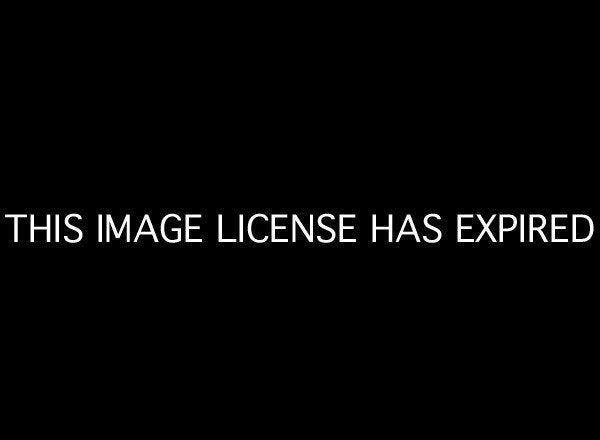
<box><xmin>1</xmin><ymin>5</ymin><xmax>598</xmax><ymax>433</ymax></box>
